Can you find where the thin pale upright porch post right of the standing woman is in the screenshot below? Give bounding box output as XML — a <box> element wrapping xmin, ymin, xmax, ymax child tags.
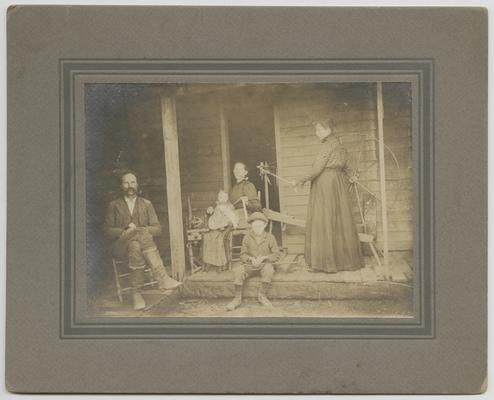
<box><xmin>376</xmin><ymin>81</ymin><xmax>390</xmax><ymax>279</ymax></box>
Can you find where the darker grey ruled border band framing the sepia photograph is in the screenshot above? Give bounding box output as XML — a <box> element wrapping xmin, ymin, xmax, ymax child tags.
<box><xmin>59</xmin><ymin>59</ymin><xmax>435</xmax><ymax>339</ymax></box>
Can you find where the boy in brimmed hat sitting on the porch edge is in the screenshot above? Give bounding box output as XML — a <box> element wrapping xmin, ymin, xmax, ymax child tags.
<box><xmin>226</xmin><ymin>212</ymin><xmax>280</xmax><ymax>311</ymax></box>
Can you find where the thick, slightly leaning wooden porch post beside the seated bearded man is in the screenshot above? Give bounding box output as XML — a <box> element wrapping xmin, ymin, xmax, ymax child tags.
<box><xmin>161</xmin><ymin>93</ymin><xmax>185</xmax><ymax>281</ymax></box>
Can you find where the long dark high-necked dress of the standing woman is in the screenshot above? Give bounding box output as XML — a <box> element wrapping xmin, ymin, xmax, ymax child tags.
<box><xmin>304</xmin><ymin>136</ymin><xmax>364</xmax><ymax>272</ymax></box>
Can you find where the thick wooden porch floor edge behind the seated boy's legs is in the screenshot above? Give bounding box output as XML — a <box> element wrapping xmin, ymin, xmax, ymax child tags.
<box><xmin>180</xmin><ymin>268</ymin><xmax>412</xmax><ymax>300</ymax></box>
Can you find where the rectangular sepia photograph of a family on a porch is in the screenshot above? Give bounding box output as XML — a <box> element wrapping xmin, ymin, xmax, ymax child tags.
<box><xmin>84</xmin><ymin>81</ymin><xmax>414</xmax><ymax>318</ymax></box>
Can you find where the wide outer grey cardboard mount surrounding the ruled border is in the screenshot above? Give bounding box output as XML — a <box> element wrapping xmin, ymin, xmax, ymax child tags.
<box><xmin>6</xmin><ymin>6</ymin><xmax>487</xmax><ymax>393</ymax></box>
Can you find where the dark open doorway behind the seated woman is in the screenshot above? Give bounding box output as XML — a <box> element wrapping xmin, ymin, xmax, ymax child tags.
<box><xmin>227</xmin><ymin>103</ymin><xmax>281</xmax><ymax>244</ymax></box>
